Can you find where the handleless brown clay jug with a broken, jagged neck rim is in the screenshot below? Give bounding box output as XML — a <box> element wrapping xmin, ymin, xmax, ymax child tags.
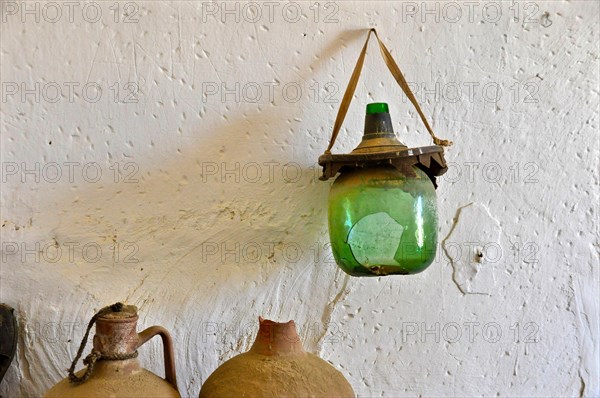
<box><xmin>200</xmin><ymin>318</ymin><xmax>356</xmax><ymax>398</ymax></box>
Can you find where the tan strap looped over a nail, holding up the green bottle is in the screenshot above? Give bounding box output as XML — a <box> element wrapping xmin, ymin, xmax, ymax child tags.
<box><xmin>325</xmin><ymin>28</ymin><xmax>452</xmax><ymax>154</ymax></box>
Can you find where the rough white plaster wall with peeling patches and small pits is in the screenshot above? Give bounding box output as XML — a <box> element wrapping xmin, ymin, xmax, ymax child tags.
<box><xmin>0</xmin><ymin>1</ymin><xmax>600</xmax><ymax>397</ymax></box>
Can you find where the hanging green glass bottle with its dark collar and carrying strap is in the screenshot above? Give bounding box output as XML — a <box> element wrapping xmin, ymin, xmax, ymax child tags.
<box><xmin>319</xmin><ymin>29</ymin><xmax>451</xmax><ymax>276</ymax></box>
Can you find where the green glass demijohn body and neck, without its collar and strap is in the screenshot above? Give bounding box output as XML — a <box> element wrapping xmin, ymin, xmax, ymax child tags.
<box><xmin>328</xmin><ymin>103</ymin><xmax>438</xmax><ymax>276</ymax></box>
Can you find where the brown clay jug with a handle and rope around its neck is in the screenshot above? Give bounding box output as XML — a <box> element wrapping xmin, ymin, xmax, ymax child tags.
<box><xmin>46</xmin><ymin>303</ymin><xmax>179</xmax><ymax>398</ymax></box>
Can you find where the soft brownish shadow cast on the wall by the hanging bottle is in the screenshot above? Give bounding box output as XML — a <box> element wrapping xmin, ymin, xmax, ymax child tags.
<box><xmin>29</xmin><ymin>30</ymin><xmax>364</xmax><ymax>294</ymax></box>
